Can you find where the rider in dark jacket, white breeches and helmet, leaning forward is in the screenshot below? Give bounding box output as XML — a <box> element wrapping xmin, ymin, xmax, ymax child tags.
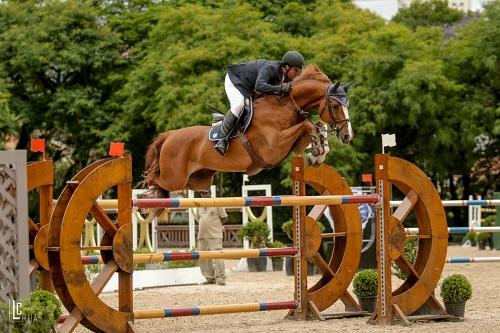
<box><xmin>214</xmin><ymin>51</ymin><xmax>304</xmax><ymax>155</ymax></box>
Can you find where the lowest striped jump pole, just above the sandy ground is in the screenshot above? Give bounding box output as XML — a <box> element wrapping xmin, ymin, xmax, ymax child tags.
<box><xmin>134</xmin><ymin>301</ymin><xmax>297</xmax><ymax>319</ymax></box>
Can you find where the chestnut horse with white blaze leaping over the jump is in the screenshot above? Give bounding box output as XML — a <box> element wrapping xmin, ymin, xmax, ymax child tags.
<box><xmin>143</xmin><ymin>65</ymin><xmax>353</xmax><ymax>193</ymax></box>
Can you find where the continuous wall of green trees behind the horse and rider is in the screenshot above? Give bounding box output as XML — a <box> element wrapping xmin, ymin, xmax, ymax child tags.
<box><xmin>0</xmin><ymin>0</ymin><xmax>500</xmax><ymax>225</ymax></box>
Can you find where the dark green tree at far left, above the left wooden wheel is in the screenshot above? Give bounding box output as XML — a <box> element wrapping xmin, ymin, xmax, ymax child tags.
<box><xmin>0</xmin><ymin>1</ymin><xmax>131</xmax><ymax>179</ymax></box>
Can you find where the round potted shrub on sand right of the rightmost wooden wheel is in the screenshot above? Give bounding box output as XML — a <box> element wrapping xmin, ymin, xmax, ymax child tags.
<box><xmin>441</xmin><ymin>274</ymin><xmax>472</xmax><ymax>318</ymax></box>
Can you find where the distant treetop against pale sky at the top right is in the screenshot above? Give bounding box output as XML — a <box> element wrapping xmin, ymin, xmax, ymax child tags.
<box><xmin>392</xmin><ymin>0</ymin><xmax>464</xmax><ymax>30</ymax></box>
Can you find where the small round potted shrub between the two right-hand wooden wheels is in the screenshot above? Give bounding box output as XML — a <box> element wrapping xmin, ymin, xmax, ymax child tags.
<box><xmin>352</xmin><ymin>269</ymin><xmax>378</xmax><ymax>313</ymax></box>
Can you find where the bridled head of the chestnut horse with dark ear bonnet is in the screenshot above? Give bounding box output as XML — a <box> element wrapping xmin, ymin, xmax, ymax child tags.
<box><xmin>319</xmin><ymin>82</ymin><xmax>354</xmax><ymax>144</ymax></box>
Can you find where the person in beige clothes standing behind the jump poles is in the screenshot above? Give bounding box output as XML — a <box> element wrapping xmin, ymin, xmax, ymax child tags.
<box><xmin>195</xmin><ymin>190</ymin><xmax>227</xmax><ymax>286</ymax></box>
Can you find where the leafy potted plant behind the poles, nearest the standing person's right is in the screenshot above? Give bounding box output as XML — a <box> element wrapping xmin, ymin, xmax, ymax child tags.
<box><xmin>236</xmin><ymin>221</ymin><xmax>271</xmax><ymax>272</ymax></box>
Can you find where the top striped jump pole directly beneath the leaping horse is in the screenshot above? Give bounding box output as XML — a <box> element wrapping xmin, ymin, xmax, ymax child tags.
<box><xmin>132</xmin><ymin>194</ymin><xmax>380</xmax><ymax>208</ymax></box>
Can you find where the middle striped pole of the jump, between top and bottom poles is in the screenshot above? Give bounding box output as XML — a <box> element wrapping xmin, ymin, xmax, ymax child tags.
<box><xmin>82</xmin><ymin>247</ymin><xmax>297</xmax><ymax>265</ymax></box>
